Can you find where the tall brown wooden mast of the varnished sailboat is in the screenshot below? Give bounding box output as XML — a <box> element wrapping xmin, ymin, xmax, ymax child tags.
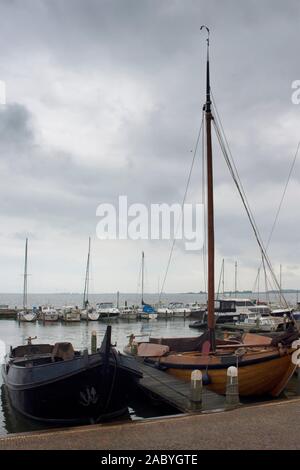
<box><xmin>200</xmin><ymin>25</ymin><xmax>216</xmax><ymax>351</ymax></box>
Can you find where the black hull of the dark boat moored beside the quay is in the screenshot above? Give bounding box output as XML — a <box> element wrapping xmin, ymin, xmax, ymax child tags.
<box><xmin>2</xmin><ymin>353</ymin><xmax>139</xmax><ymax>423</ymax></box>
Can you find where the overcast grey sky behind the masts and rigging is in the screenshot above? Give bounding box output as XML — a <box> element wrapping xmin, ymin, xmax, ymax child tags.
<box><xmin>0</xmin><ymin>0</ymin><xmax>300</xmax><ymax>293</ymax></box>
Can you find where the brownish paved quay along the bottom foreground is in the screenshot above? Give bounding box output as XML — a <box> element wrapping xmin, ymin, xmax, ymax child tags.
<box><xmin>0</xmin><ymin>398</ymin><xmax>300</xmax><ymax>450</ymax></box>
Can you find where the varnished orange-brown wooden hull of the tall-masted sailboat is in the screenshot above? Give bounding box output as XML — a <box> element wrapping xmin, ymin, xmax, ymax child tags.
<box><xmin>160</xmin><ymin>352</ymin><xmax>296</xmax><ymax>396</ymax></box>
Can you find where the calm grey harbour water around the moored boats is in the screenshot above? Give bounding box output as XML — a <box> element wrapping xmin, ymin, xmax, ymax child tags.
<box><xmin>0</xmin><ymin>294</ymin><xmax>296</xmax><ymax>435</ymax></box>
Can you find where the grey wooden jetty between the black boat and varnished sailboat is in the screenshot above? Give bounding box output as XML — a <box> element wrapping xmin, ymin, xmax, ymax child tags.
<box><xmin>139</xmin><ymin>362</ymin><xmax>225</xmax><ymax>413</ymax></box>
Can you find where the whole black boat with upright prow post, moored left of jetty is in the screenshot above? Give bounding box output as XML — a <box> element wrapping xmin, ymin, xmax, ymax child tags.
<box><xmin>2</xmin><ymin>326</ymin><xmax>142</xmax><ymax>423</ymax></box>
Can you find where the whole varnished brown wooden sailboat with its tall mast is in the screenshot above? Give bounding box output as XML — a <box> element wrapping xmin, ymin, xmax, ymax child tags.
<box><xmin>134</xmin><ymin>26</ymin><xmax>298</xmax><ymax>396</ymax></box>
